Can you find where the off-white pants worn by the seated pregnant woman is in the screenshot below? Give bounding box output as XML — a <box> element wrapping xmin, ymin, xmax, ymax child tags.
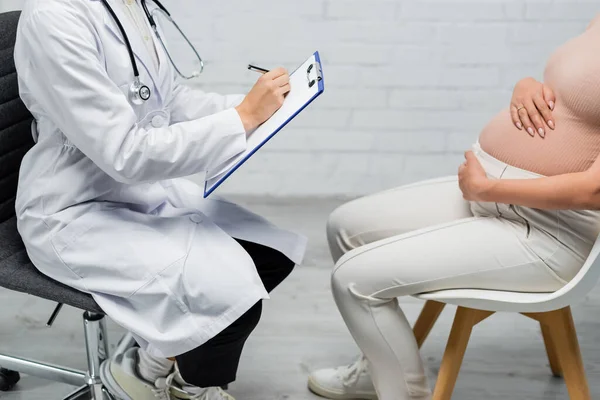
<box><xmin>327</xmin><ymin>145</ymin><xmax>600</xmax><ymax>400</ymax></box>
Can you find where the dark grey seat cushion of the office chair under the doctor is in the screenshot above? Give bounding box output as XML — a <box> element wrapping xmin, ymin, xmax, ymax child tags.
<box><xmin>0</xmin><ymin>217</ymin><xmax>104</xmax><ymax>314</ymax></box>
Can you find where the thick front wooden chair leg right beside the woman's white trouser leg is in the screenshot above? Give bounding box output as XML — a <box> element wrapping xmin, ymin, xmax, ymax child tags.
<box><xmin>433</xmin><ymin>307</ymin><xmax>494</xmax><ymax>400</ymax></box>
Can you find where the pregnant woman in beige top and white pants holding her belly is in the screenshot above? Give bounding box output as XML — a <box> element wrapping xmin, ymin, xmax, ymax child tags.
<box><xmin>309</xmin><ymin>14</ymin><xmax>600</xmax><ymax>400</ymax></box>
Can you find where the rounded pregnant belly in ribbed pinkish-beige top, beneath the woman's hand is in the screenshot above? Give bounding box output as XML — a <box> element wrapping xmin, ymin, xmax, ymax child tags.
<box><xmin>479</xmin><ymin>106</ymin><xmax>600</xmax><ymax>176</ymax></box>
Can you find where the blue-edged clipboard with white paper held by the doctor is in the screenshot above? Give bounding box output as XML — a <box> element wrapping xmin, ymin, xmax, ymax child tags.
<box><xmin>204</xmin><ymin>51</ymin><xmax>325</xmax><ymax>198</ymax></box>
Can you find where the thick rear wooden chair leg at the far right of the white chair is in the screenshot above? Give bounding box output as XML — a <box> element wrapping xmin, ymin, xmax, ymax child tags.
<box><xmin>525</xmin><ymin>307</ymin><xmax>592</xmax><ymax>400</ymax></box>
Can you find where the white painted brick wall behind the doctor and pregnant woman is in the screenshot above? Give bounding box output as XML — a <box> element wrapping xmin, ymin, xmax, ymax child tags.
<box><xmin>0</xmin><ymin>0</ymin><xmax>600</xmax><ymax>195</ymax></box>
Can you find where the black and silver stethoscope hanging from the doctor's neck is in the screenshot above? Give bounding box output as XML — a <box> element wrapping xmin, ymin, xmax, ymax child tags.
<box><xmin>102</xmin><ymin>0</ymin><xmax>204</xmax><ymax>105</ymax></box>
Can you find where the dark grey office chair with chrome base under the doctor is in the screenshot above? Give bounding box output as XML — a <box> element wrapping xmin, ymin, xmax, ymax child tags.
<box><xmin>0</xmin><ymin>12</ymin><xmax>135</xmax><ymax>400</ymax></box>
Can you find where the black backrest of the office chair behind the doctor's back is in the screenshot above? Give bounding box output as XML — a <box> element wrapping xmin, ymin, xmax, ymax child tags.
<box><xmin>0</xmin><ymin>11</ymin><xmax>33</xmax><ymax>223</ymax></box>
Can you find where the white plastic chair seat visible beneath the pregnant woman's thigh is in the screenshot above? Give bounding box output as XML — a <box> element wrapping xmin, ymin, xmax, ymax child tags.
<box><xmin>414</xmin><ymin>289</ymin><xmax>555</xmax><ymax>312</ymax></box>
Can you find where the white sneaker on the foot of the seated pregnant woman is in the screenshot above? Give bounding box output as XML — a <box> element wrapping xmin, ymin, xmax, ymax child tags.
<box><xmin>308</xmin><ymin>357</ymin><xmax>377</xmax><ymax>400</ymax></box>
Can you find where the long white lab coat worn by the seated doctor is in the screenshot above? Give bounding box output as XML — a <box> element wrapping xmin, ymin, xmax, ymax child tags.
<box><xmin>15</xmin><ymin>0</ymin><xmax>306</xmax><ymax>357</ymax></box>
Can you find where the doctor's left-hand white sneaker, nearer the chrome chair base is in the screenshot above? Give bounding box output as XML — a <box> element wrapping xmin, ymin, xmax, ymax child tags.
<box><xmin>100</xmin><ymin>347</ymin><xmax>171</xmax><ymax>400</ymax></box>
